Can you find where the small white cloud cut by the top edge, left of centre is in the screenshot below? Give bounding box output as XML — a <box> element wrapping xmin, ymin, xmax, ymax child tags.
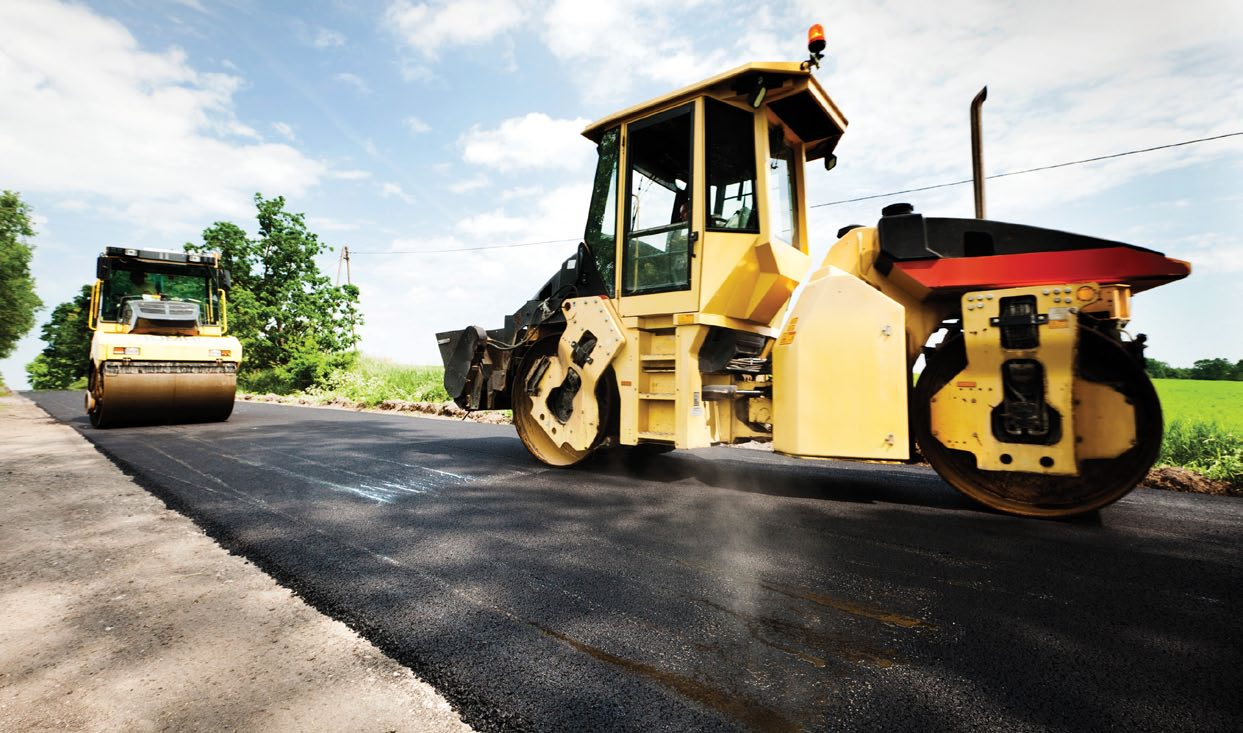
<box><xmin>384</xmin><ymin>0</ymin><xmax>523</xmax><ymax>58</ymax></box>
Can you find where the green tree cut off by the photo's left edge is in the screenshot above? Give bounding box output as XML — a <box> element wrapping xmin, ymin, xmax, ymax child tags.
<box><xmin>0</xmin><ymin>191</ymin><xmax>44</xmax><ymax>359</ymax></box>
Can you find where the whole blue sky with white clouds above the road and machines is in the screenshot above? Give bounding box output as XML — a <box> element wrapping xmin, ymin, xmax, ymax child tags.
<box><xmin>0</xmin><ymin>0</ymin><xmax>1243</xmax><ymax>386</ymax></box>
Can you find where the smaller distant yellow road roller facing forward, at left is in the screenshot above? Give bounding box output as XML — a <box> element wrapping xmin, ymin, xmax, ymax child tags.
<box><xmin>86</xmin><ymin>247</ymin><xmax>241</xmax><ymax>427</ymax></box>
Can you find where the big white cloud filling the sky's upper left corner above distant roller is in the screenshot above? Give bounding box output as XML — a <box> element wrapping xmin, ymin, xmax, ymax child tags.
<box><xmin>0</xmin><ymin>0</ymin><xmax>328</xmax><ymax>231</ymax></box>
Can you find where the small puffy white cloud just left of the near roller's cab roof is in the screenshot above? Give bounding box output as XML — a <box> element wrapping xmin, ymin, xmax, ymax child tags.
<box><xmin>457</xmin><ymin>112</ymin><xmax>594</xmax><ymax>171</ymax></box>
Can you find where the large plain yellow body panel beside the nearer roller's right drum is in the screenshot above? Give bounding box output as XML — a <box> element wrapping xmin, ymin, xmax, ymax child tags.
<box><xmin>772</xmin><ymin>265</ymin><xmax>910</xmax><ymax>460</ymax></box>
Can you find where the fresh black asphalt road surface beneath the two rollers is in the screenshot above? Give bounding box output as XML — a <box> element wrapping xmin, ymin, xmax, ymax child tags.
<box><xmin>30</xmin><ymin>393</ymin><xmax>1243</xmax><ymax>732</ymax></box>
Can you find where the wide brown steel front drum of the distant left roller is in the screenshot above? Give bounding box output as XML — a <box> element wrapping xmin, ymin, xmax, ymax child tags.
<box><xmin>87</xmin><ymin>363</ymin><xmax>237</xmax><ymax>427</ymax></box>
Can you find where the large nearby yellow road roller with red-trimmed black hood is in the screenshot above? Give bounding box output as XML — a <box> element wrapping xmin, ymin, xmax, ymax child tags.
<box><xmin>438</xmin><ymin>37</ymin><xmax>1190</xmax><ymax>516</ymax></box>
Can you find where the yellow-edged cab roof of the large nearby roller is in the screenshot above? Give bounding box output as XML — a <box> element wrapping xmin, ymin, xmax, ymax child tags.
<box><xmin>583</xmin><ymin>61</ymin><xmax>846</xmax><ymax>160</ymax></box>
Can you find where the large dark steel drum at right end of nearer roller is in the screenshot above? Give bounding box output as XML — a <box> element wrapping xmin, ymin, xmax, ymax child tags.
<box><xmin>912</xmin><ymin>328</ymin><xmax>1162</xmax><ymax>517</ymax></box>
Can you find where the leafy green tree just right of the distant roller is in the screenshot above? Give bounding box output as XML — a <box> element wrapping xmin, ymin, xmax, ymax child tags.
<box><xmin>186</xmin><ymin>194</ymin><xmax>362</xmax><ymax>389</ymax></box>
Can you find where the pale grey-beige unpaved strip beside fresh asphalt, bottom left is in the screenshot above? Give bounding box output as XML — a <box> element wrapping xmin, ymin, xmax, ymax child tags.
<box><xmin>0</xmin><ymin>395</ymin><xmax>470</xmax><ymax>733</ymax></box>
